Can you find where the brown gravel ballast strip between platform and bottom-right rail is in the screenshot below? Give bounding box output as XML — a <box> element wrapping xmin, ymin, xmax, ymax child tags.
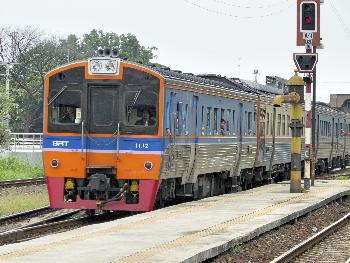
<box><xmin>207</xmin><ymin>197</ymin><xmax>350</xmax><ymax>263</ymax></box>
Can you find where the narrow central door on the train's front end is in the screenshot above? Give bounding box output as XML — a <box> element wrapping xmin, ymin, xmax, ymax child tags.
<box><xmin>86</xmin><ymin>86</ymin><xmax>120</xmax><ymax>167</ymax></box>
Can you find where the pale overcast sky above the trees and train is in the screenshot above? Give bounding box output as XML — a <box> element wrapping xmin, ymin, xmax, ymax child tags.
<box><xmin>0</xmin><ymin>0</ymin><xmax>350</xmax><ymax>102</ymax></box>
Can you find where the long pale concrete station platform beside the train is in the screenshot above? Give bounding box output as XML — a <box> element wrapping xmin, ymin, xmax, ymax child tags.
<box><xmin>0</xmin><ymin>180</ymin><xmax>350</xmax><ymax>263</ymax></box>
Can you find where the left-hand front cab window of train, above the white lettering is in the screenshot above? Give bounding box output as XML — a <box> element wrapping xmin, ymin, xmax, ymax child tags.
<box><xmin>49</xmin><ymin>89</ymin><xmax>81</xmax><ymax>125</ymax></box>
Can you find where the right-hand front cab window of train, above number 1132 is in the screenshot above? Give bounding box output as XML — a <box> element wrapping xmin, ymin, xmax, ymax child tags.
<box><xmin>125</xmin><ymin>89</ymin><xmax>157</xmax><ymax>126</ymax></box>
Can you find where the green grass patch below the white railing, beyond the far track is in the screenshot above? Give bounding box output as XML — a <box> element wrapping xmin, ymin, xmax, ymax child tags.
<box><xmin>0</xmin><ymin>157</ymin><xmax>44</xmax><ymax>181</ymax></box>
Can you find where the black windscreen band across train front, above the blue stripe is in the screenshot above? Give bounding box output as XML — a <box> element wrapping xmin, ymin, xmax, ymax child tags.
<box><xmin>48</xmin><ymin>67</ymin><xmax>160</xmax><ymax>135</ymax></box>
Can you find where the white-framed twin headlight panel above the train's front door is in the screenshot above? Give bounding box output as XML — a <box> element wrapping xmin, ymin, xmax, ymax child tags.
<box><xmin>88</xmin><ymin>57</ymin><xmax>120</xmax><ymax>75</ymax></box>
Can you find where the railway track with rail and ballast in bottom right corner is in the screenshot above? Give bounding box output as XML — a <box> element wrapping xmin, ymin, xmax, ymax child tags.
<box><xmin>272</xmin><ymin>213</ymin><xmax>350</xmax><ymax>263</ymax></box>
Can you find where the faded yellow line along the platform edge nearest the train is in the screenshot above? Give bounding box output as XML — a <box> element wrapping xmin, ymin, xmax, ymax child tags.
<box><xmin>0</xmin><ymin>185</ymin><xmax>282</xmax><ymax>261</ymax></box>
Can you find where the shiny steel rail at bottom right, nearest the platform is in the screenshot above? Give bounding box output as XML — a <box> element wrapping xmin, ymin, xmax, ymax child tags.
<box><xmin>271</xmin><ymin>213</ymin><xmax>350</xmax><ymax>263</ymax></box>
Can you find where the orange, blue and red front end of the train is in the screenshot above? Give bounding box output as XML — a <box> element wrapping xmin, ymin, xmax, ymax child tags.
<box><xmin>43</xmin><ymin>56</ymin><xmax>164</xmax><ymax>211</ymax></box>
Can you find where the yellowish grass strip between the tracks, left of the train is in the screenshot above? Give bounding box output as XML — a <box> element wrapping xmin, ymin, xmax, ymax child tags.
<box><xmin>0</xmin><ymin>189</ymin><xmax>49</xmax><ymax>216</ymax></box>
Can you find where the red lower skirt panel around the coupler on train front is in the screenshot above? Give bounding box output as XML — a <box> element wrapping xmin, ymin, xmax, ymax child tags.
<box><xmin>46</xmin><ymin>177</ymin><xmax>159</xmax><ymax>211</ymax></box>
